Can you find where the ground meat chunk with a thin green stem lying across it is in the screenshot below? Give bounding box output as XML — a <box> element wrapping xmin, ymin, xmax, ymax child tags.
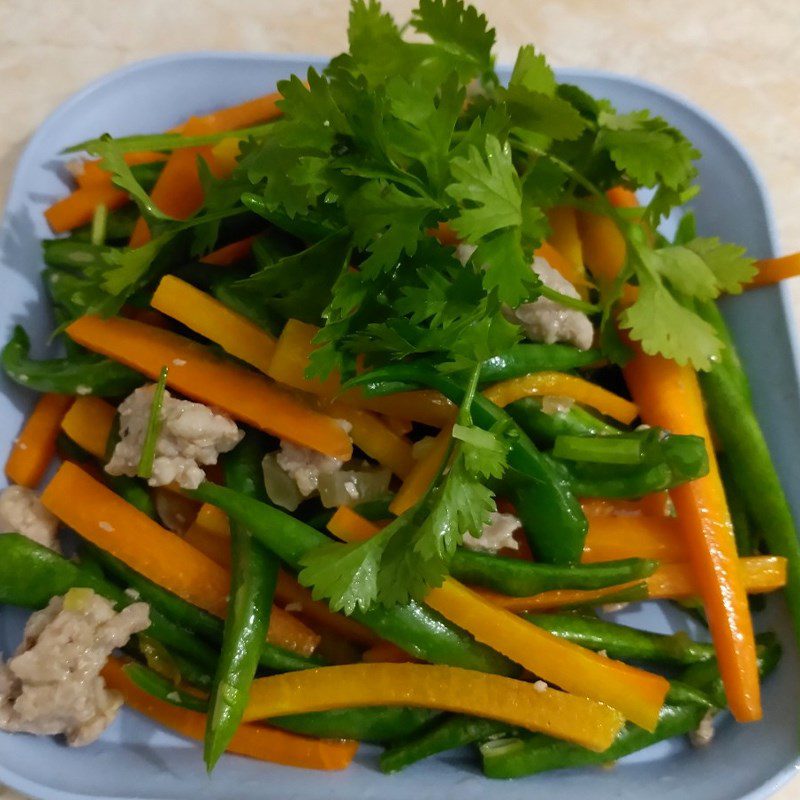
<box><xmin>106</xmin><ymin>384</ymin><xmax>244</xmax><ymax>489</ymax></box>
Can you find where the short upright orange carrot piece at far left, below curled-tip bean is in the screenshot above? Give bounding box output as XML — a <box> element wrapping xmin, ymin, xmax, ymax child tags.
<box><xmin>6</xmin><ymin>394</ymin><xmax>72</xmax><ymax>489</ymax></box>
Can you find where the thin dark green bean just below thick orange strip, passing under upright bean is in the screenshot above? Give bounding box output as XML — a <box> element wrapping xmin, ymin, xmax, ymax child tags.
<box><xmin>87</xmin><ymin>545</ymin><xmax>324</xmax><ymax>672</ymax></box>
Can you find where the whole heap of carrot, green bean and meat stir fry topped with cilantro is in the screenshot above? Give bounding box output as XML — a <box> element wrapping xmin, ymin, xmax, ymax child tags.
<box><xmin>0</xmin><ymin>0</ymin><xmax>800</xmax><ymax>778</ymax></box>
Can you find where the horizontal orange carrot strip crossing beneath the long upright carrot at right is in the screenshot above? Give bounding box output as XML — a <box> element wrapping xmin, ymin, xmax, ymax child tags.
<box><xmin>482</xmin><ymin>556</ymin><xmax>786</xmax><ymax>613</ymax></box>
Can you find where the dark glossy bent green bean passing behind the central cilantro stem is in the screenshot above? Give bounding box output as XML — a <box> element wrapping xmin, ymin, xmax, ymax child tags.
<box><xmin>350</xmin><ymin>364</ymin><xmax>587</xmax><ymax>564</ymax></box>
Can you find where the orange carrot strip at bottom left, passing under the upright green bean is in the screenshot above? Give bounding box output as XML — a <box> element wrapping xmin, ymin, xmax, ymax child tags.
<box><xmin>102</xmin><ymin>658</ymin><xmax>358</xmax><ymax>770</ymax></box>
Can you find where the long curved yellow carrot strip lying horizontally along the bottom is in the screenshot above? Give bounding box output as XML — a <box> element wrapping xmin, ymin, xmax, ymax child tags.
<box><xmin>244</xmin><ymin>660</ymin><xmax>623</xmax><ymax>752</ymax></box>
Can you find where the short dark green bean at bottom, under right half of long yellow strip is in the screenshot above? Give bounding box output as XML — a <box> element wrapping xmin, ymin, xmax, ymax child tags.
<box><xmin>380</xmin><ymin>716</ymin><xmax>506</xmax><ymax>773</ymax></box>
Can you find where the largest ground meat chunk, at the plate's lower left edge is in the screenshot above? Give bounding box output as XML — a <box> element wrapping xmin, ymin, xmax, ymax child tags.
<box><xmin>0</xmin><ymin>589</ymin><xmax>150</xmax><ymax>746</ymax></box>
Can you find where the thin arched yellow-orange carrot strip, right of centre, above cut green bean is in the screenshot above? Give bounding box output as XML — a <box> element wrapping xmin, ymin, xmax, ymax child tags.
<box><xmin>483</xmin><ymin>372</ymin><xmax>639</xmax><ymax>425</ymax></box>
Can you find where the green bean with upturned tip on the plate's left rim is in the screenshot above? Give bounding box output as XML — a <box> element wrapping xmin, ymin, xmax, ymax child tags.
<box><xmin>0</xmin><ymin>325</ymin><xmax>144</xmax><ymax>397</ymax></box>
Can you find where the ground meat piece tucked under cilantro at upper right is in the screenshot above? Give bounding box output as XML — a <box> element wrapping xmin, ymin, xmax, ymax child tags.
<box><xmin>506</xmin><ymin>258</ymin><xmax>594</xmax><ymax>350</ymax></box>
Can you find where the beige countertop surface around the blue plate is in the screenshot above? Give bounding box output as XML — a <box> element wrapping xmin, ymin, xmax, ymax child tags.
<box><xmin>0</xmin><ymin>0</ymin><xmax>800</xmax><ymax>800</ymax></box>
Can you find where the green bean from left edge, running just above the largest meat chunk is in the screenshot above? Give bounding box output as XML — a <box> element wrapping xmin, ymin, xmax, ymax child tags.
<box><xmin>0</xmin><ymin>533</ymin><xmax>216</xmax><ymax>668</ymax></box>
